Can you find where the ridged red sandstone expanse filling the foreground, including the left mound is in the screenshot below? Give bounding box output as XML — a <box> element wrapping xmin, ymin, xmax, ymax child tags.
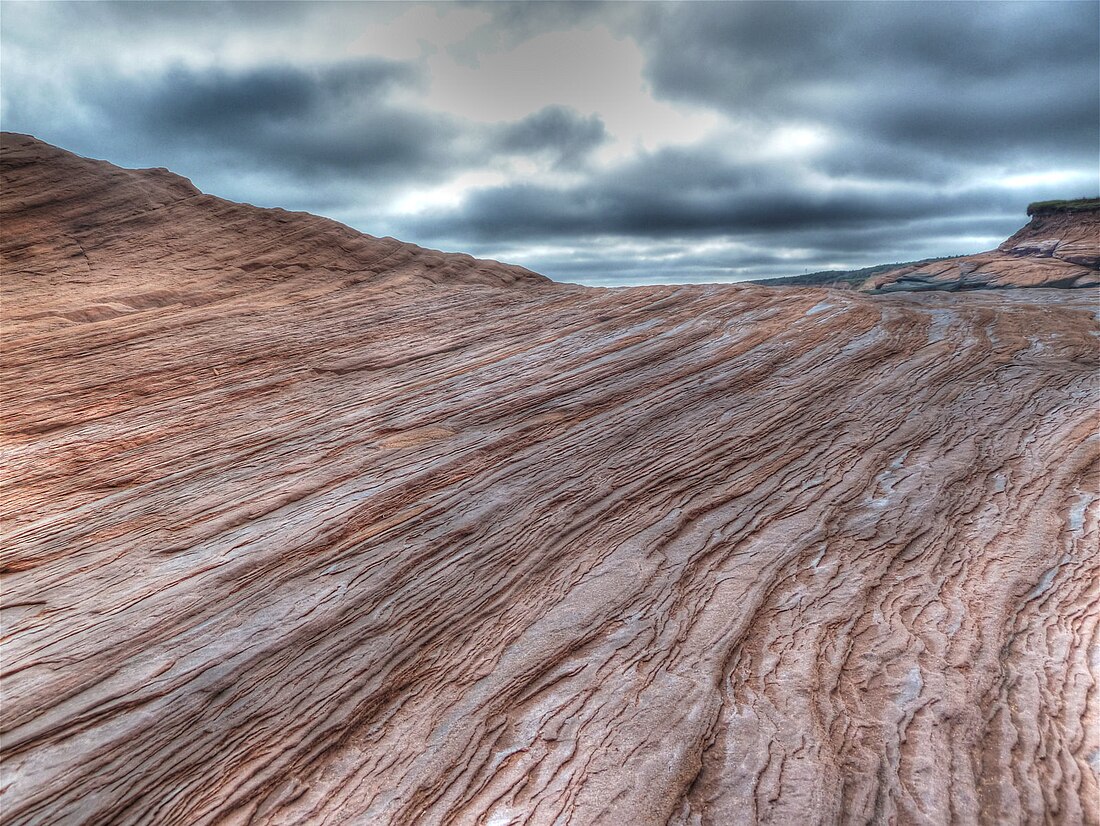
<box><xmin>0</xmin><ymin>132</ymin><xmax>1100</xmax><ymax>826</ymax></box>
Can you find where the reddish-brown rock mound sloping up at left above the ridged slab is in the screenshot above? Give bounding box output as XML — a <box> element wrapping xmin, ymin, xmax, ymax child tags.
<box><xmin>0</xmin><ymin>133</ymin><xmax>550</xmax><ymax>336</ymax></box>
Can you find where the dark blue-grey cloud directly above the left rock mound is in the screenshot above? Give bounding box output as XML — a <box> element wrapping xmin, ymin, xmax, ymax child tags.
<box><xmin>72</xmin><ymin>59</ymin><xmax>457</xmax><ymax>181</ymax></box>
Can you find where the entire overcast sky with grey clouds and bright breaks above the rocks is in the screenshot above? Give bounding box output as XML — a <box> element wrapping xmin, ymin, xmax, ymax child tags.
<box><xmin>0</xmin><ymin>0</ymin><xmax>1100</xmax><ymax>285</ymax></box>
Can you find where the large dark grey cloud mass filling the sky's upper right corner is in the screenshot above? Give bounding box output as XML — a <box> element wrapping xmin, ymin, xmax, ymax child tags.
<box><xmin>638</xmin><ymin>2</ymin><xmax>1100</xmax><ymax>159</ymax></box>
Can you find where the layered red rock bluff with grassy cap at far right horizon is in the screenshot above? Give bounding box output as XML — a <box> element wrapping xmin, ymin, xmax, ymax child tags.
<box><xmin>864</xmin><ymin>200</ymin><xmax>1100</xmax><ymax>293</ymax></box>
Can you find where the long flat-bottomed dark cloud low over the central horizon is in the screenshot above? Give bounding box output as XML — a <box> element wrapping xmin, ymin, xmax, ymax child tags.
<box><xmin>415</xmin><ymin>139</ymin><xmax>1022</xmax><ymax>240</ymax></box>
